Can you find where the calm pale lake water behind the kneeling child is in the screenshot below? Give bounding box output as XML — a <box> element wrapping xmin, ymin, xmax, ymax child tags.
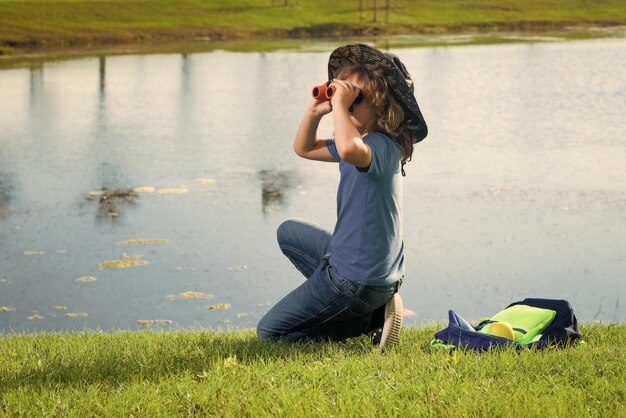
<box><xmin>0</xmin><ymin>39</ymin><xmax>626</xmax><ymax>332</ymax></box>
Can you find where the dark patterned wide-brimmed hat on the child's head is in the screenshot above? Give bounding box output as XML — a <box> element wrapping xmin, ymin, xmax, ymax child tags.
<box><xmin>328</xmin><ymin>44</ymin><xmax>428</xmax><ymax>143</ymax></box>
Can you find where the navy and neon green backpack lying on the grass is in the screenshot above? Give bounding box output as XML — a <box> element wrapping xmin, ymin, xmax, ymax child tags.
<box><xmin>428</xmin><ymin>298</ymin><xmax>582</xmax><ymax>351</ymax></box>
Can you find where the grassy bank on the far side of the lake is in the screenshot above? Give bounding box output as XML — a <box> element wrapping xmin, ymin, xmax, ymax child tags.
<box><xmin>0</xmin><ymin>0</ymin><xmax>626</xmax><ymax>55</ymax></box>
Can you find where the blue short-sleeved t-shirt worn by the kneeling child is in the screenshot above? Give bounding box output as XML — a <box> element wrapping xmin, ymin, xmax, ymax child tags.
<box><xmin>326</xmin><ymin>132</ymin><xmax>404</xmax><ymax>286</ymax></box>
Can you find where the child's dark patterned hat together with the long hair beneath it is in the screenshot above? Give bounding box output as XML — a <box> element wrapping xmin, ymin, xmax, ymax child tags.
<box><xmin>328</xmin><ymin>44</ymin><xmax>428</xmax><ymax>170</ymax></box>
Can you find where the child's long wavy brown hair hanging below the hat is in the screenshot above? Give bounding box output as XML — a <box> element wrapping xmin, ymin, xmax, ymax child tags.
<box><xmin>338</xmin><ymin>66</ymin><xmax>418</xmax><ymax>176</ymax></box>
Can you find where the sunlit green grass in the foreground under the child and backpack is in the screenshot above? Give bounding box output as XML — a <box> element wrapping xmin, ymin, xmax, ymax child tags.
<box><xmin>0</xmin><ymin>324</ymin><xmax>626</xmax><ymax>417</ymax></box>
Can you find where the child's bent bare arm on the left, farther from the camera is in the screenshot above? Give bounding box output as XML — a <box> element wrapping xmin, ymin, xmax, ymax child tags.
<box><xmin>293</xmin><ymin>99</ymin><xmax>336</xmax><ymax>162</ymax></box>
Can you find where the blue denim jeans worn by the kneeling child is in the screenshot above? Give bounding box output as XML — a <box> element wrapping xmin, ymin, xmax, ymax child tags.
<box><xmin>257</xmin><ymin>219</ymin><xmax>397</xmax><ymax>341</ymax></box>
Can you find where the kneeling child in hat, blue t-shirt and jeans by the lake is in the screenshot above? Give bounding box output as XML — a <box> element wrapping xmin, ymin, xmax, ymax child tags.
<box><xmin>257</xmin><ymin>44</ymin><xmax>428</xmax><ymax>347</ymax></box>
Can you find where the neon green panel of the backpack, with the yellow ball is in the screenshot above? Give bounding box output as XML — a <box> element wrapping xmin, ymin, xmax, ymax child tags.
<box><xmin>477</xmin><ymin>305</ymin><xmax>556</xmax><ymax>344</ymax></box>
